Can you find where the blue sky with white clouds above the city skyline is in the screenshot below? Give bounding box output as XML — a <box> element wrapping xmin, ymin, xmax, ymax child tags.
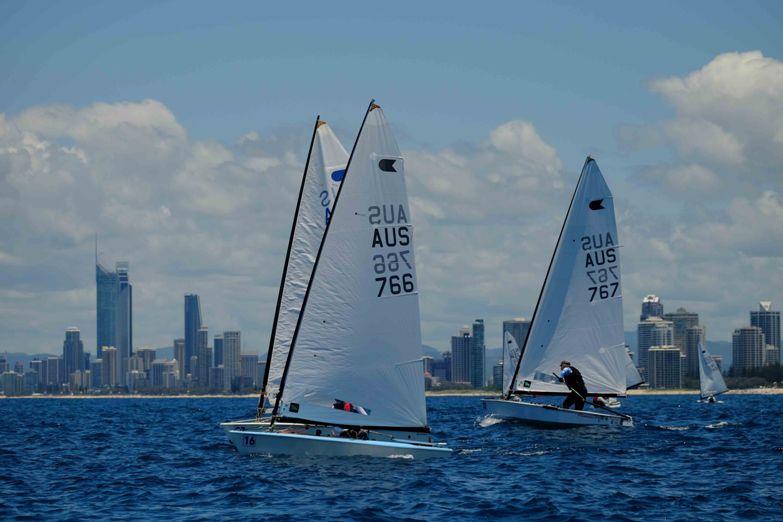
<box><xmin>0</xmin><ymin>1</ymin><xmax>783</xmax><ymax>353</ymax></box>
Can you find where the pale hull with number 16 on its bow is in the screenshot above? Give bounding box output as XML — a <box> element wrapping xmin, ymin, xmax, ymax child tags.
<box><xmin>228</xmin><ymin>430</ymin><xmax>452</xmax><ymax>459</ymax></box>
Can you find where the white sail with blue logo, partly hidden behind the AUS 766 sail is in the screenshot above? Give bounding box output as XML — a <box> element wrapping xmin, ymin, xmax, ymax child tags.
<box><xmin>264</xmin><ymin>120</ymin><xmax>348</xmax><ymax>403</ymax></box>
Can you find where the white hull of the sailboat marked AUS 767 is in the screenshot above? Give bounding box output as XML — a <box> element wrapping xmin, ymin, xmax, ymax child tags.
<box><xmin>481</xmin><ymin>399</ymin><xmax>633</xmax><ymax>427</ymax></box>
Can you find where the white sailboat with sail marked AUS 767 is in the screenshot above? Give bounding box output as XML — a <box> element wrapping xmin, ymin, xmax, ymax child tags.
<box><xmin>482</xmin><ymin>157</ymin><xmax>633</xmax><ymax>426</ymax></box>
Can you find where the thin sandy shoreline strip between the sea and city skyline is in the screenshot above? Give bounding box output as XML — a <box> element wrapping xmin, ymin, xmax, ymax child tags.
<box><xmin>0</xmin><ymin>388</ymin><xmax>783</xmax><ymax>400</ymax></box>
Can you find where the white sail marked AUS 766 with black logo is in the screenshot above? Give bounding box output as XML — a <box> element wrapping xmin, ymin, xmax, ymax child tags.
<box><xmin>277</xmin><ymin>105</ymin><xmax>427</xmax><ymax>428</ymax></box>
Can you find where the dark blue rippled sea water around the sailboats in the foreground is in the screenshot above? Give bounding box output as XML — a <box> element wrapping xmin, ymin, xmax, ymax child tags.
<box><xmin>0</xmin><ymin>395</ymin><xmax>783</xmax><ymax>520</ymax></box>
